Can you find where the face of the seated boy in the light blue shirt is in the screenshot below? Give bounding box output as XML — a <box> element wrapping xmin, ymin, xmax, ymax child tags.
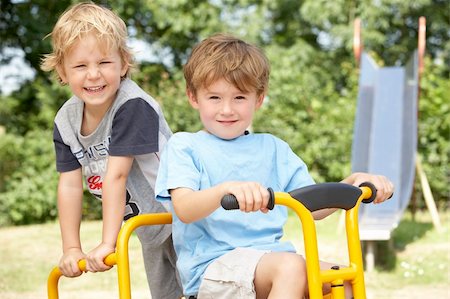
<box><xmin>188</xmin><ymin>79</ymin><xmax>264</xmax><ymax>139</ymax></box>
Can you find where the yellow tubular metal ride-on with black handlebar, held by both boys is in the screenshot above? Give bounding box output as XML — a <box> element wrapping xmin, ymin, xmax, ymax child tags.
<box><xmin>47</xmin><ymin>183</ymin><xmax>376</xmax><ymax>299</ymax></box>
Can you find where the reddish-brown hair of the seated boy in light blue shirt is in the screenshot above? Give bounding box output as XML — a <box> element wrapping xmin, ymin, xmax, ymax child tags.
<box><xmin>183</xmin><ymin>33</ymin><xmax>270</xmax><ymax>95</ymax></box>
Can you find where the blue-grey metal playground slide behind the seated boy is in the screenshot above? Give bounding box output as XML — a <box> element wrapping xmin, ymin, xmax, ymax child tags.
<box><xmin>352</xmin><ymin>51</ymin><xmax>419</xmax><ymax>240</ymax></box>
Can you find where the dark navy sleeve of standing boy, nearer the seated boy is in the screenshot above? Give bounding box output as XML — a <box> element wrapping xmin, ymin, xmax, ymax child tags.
<box><xmin>109</xmin><ymin>98</ymin><xmax>159</xmax><ymax>156</ymax></box>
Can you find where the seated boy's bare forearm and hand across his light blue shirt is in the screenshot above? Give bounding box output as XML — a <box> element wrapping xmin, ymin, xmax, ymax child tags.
<box><xmin>170</xmin><ymin>182</ymin><xmax>269</xmax><ymax>223</ymax></box>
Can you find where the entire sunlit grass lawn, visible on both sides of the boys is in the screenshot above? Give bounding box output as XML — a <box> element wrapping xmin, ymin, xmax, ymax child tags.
<box><xmin>0</xmin><ymin>211</ymin><xmax>450</xmax><ymax>299</ymax></box>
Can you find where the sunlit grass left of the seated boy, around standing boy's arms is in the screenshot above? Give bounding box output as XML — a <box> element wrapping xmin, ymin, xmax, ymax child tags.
<box><xmin>0</xmin><ymin>221</ymin><xmax>150</xmax><ymax>299</ymax></box>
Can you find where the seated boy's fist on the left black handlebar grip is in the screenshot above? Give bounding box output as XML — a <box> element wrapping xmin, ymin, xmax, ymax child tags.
<box><xmin>228</xmin><ymin>182</ymin><xmax>270</xmax><ymax>213</ymax></box>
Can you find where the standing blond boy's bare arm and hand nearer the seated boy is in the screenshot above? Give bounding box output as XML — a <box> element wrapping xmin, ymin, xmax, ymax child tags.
<box><xmin>86</xmin><ymin>156</ymin><xmax>134</xmax><ymax>272</ymax></box>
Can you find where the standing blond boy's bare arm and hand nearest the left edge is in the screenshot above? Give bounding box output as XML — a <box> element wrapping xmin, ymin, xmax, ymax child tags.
<box><xmin>58</xmin><ymin>168</ymin><xmax>85</xmax><ymax>277</ymax></box>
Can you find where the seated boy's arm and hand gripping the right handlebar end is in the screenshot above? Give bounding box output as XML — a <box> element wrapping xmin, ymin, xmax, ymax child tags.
<box><xmin>312</xmin><ymin>172</ymin><xmax>394</xmax><ymax>220</ymax></box>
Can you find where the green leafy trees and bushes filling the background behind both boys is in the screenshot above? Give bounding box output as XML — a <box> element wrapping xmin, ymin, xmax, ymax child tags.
<box><xmin>0</xmin><ymin>0</ymin><xmax>450</xmax><ymax>225</ymax></box>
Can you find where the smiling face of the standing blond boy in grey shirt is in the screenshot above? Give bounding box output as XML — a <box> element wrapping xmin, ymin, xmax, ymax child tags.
<box><xmin>57</xmin><ymin>34</ymin><xmax>128</xmax><ymax>111</ymax></box>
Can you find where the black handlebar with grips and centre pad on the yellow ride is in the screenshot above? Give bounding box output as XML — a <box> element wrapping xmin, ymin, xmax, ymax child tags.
<box><xmin>221</xmin><ymin>182</ymin><xmax>377</xmax><ymax>212</ymax></box>
